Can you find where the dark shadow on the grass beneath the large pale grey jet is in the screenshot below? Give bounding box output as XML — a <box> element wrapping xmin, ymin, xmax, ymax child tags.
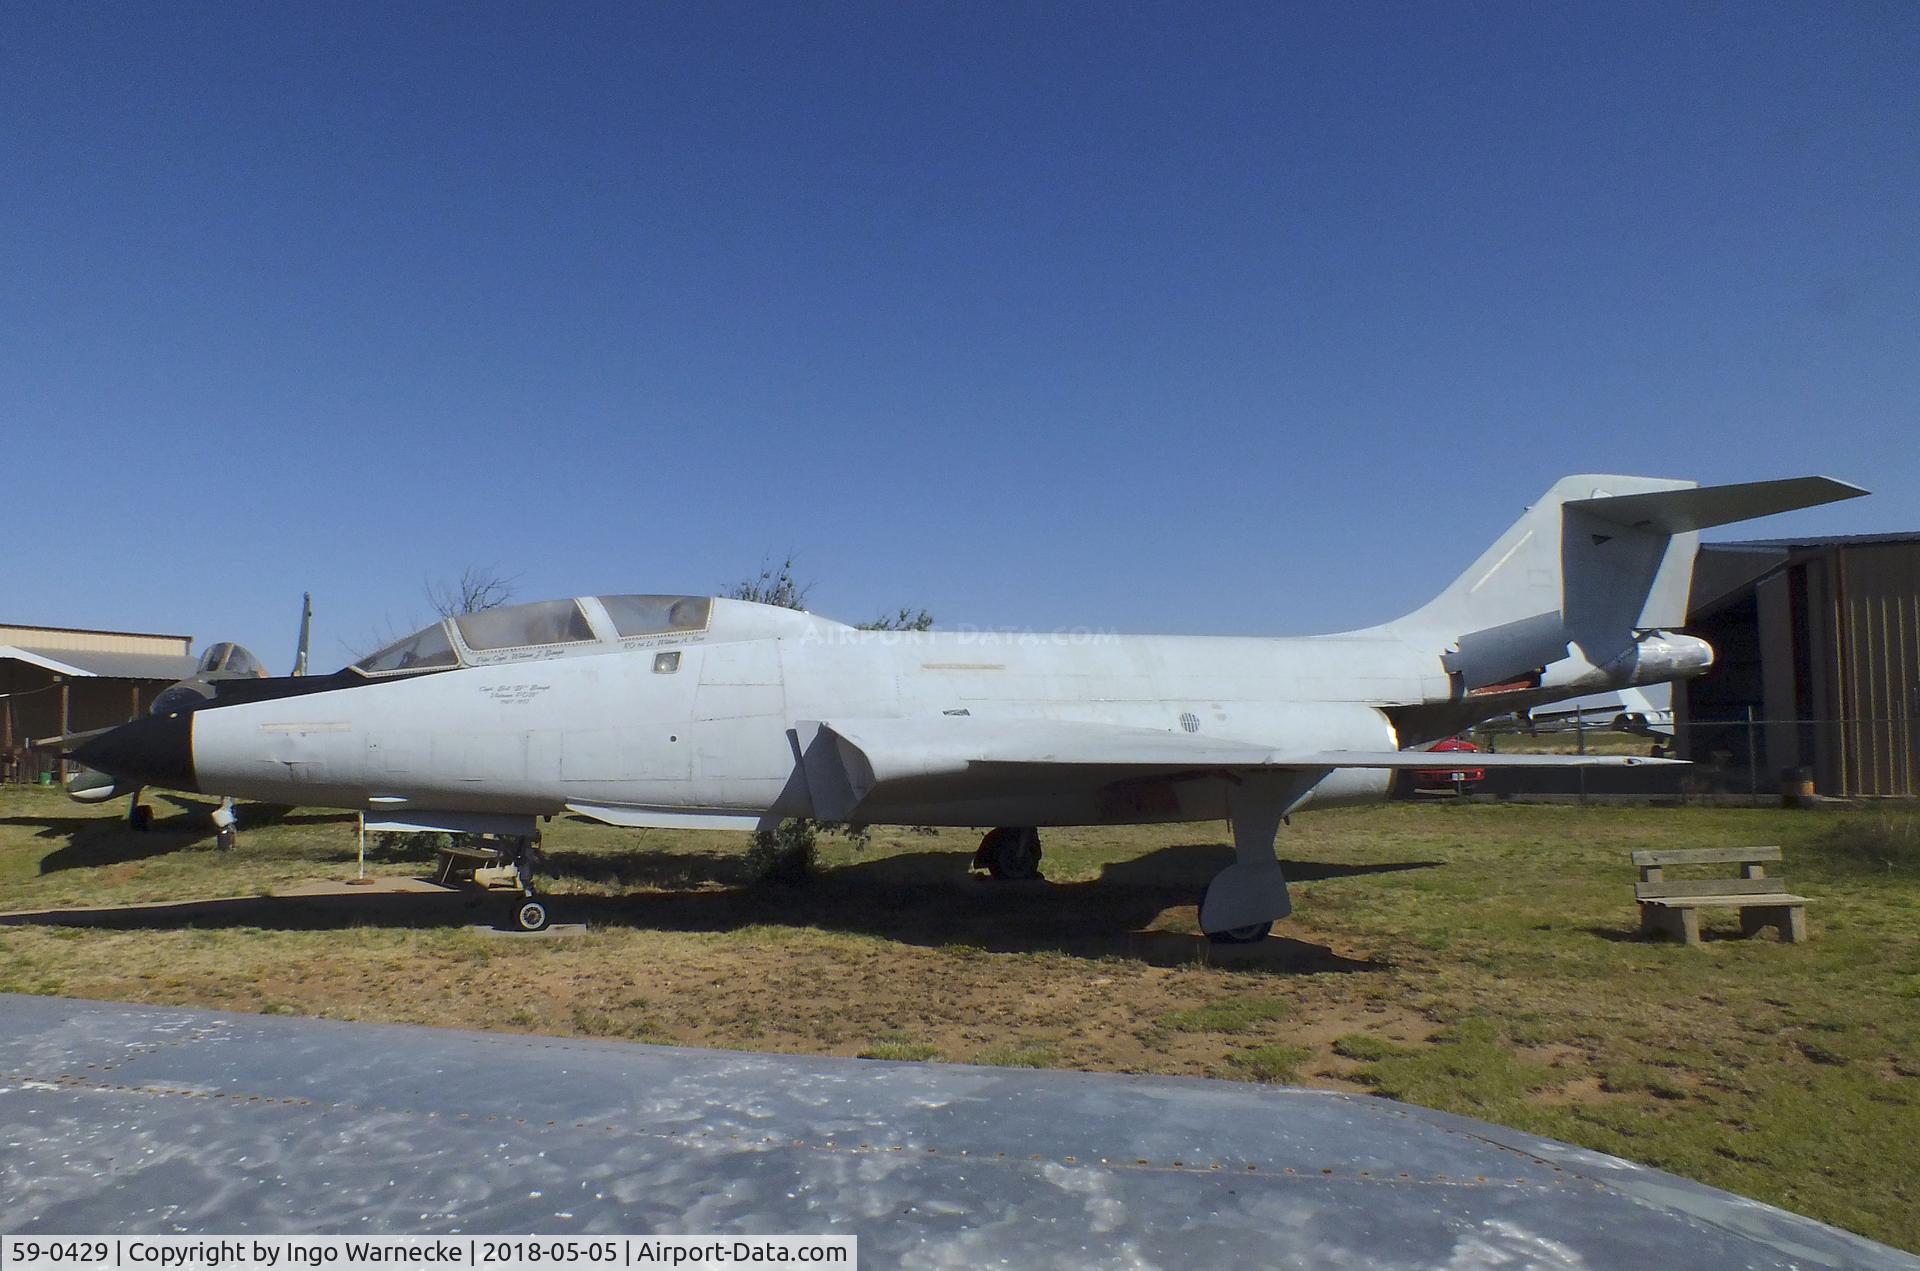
<box><xmin>0</xmin><ymin>837</ymin><xmax>1440</xmax><ymax>971</ymax></box>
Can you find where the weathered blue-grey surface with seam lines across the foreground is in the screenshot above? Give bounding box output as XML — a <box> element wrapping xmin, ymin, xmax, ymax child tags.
<box><xmin>0</xmin><ymin>995</ymin><xmax>1920</xmax><ymax>1269</ymax></box>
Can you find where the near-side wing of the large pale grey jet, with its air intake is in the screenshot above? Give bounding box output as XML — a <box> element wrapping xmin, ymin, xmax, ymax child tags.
<box><xmin>795</xmin><ymin>716</ymin><xmax>1682</xmax><ymax>820</ymax></box>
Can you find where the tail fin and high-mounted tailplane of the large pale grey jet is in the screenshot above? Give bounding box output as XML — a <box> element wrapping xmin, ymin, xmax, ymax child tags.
<box><xmin>1388</xmin><ymin>476</ymin><xmax>1866</xmax><ymax>691</ymax></box>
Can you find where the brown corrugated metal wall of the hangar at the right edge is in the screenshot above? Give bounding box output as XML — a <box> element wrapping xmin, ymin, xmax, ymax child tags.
<box><xmin>1812</xmin><ymin>543</ymin><xmax>1920</xmax><ymax>799</ymax></box>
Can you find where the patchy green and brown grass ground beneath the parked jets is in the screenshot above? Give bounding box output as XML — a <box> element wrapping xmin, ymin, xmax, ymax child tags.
<box><xmin>0</xmin><ymin>789</ymin><xmax>1920</xmax><ymax>1248</ymax></box>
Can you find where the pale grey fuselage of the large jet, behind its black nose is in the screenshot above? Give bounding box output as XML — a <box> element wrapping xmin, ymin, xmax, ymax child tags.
<box><xmin>93</xmin><ymin>597</ymin><xmax>1711</xmax><ymax>826</ymax></box>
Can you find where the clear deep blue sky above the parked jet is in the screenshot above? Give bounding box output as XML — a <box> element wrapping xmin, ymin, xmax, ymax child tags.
<box><xmin>0</xmin><ymin>2</ymin><xmax>1920</xmax><ymax>670</ymax></box>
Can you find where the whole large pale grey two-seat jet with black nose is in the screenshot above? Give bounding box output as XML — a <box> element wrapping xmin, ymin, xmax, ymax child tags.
<box><xmin>60</xmin><ymin>476</ymin><xmax>1866</xmax><ymax>941</ymax></box>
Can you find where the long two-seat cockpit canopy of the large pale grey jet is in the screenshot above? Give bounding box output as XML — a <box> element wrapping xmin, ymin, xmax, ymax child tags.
<box><xmin>353</xmin><ymin>595</ymin><xmax>712</xmax><ymax>676</ymax></box>
